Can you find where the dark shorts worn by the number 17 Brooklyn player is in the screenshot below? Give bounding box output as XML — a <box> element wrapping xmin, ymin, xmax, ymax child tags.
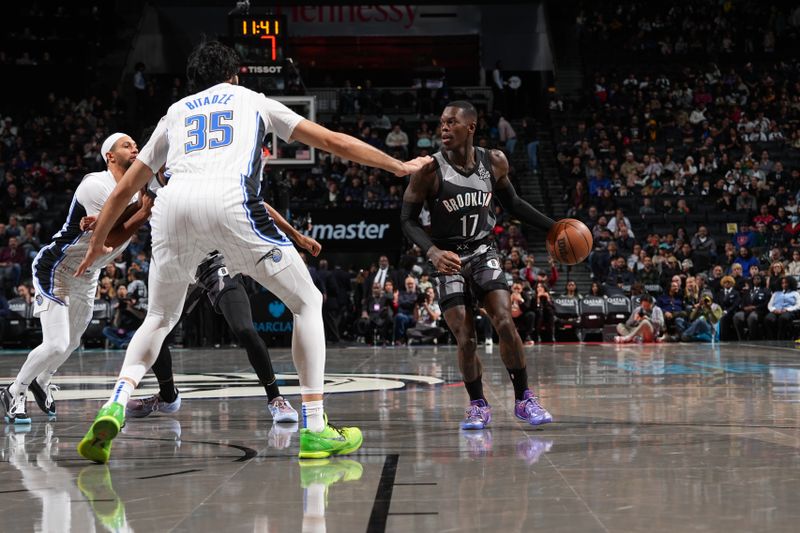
<box><xmin>431</xmin><ymin>245</ymin><xmax>509</xmax><ymax>312</ymax></box>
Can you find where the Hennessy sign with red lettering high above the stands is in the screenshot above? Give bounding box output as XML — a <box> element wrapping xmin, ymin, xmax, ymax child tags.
<box><xmin>274</xmin><ymin>4</ymin><xmax>481</xmax><ymax>37</ymax></box>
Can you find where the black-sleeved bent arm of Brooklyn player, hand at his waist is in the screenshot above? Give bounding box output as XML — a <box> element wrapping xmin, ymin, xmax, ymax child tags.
<box><xmin>400</xmin><ymin>163</ymin><xmax>461</xmax><ymax>274</ymax></box>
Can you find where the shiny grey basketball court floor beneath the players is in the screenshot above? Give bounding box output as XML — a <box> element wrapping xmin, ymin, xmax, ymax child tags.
<box><xmin>0</xmin><ymin>344</ymin><xmax>800</xmax><ymax>533</ymax></box>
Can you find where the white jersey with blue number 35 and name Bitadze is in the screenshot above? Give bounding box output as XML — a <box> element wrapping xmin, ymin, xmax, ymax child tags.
<box><xmin>138</xmin><ymin>83</ymin><xmax>303</xmax><ymax>190</ymax></box>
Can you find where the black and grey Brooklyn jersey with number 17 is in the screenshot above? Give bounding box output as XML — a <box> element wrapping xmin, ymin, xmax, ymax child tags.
<box><xmin>428</xmin><ymin>146</ymin><xmax>496</xmax><ymax>253</ymax></box>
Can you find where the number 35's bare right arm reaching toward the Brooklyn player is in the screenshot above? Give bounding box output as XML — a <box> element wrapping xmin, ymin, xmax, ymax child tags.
<box><xmin>291</xmin><ymin>120</ymin><xmax>431</xmax><ymax>176</ymax></box>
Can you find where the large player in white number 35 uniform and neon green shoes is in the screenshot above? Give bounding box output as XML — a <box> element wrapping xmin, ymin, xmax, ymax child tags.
<box><xmin>78</xmin><ymin>42</ymin><xmax>430</xmax><ymax>462</ymax></box>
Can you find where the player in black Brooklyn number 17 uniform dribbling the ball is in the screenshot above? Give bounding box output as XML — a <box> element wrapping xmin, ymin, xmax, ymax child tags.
<box><xmin>401</xmin><ymin>101</ymin><xmax>554</xmax><ymax>429</ymax></box>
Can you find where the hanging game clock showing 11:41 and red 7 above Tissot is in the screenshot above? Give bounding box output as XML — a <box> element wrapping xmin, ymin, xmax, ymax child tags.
<box><xmin>228</xmin><ymin>13</ymin><xmax>288</xmax><ymax>93</ymax></box>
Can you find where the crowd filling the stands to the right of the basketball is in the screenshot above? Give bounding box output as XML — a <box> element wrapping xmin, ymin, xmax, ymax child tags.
<box><xmin>555</xmin><ymin>2</ymin><xmax>800</xmax><ymax>342</ymax></box>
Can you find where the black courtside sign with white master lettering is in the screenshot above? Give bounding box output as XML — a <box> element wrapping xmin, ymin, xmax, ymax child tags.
<box><xmin>306</xmin><ymin>209</ymin><xmax>402</xmax><ymax>252</ymax></box>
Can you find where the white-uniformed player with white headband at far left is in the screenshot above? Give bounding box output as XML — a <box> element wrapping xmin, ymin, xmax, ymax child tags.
<box><xmin>0</xmin><ymin>133</ymin><xmax>153</xmax><ymax>424</ymax></box>
